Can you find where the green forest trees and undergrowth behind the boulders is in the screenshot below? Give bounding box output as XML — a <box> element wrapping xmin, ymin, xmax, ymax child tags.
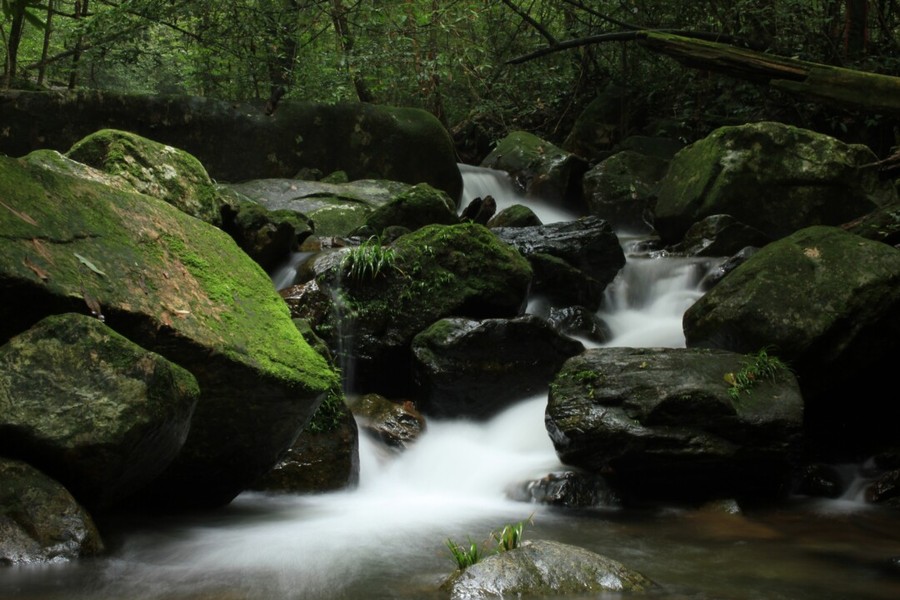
<box><xmin>0</xmin><ymin>0</ymin><xmax>900</xmax><ymax>161</ymax></box>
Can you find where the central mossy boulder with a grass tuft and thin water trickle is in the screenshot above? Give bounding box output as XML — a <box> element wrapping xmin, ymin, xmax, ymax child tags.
<box><xmin>306</xmin><ymin>223</ymin><xmax>532</xmax><ymax>396</ymax></box>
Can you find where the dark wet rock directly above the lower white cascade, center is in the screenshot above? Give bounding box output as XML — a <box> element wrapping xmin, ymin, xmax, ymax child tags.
<box><xmin>412</xmin><ymin>315</ymin><xmax>584</xmax><ymax>418</ymax></box>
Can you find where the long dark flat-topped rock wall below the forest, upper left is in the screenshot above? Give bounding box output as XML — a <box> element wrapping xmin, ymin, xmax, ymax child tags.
<box><xmin>0</xmin><ymin>90</ymin><xmax>462</xmax><ymax>199</ymax></box>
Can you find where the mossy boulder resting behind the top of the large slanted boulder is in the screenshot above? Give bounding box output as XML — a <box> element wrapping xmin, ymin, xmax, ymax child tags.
<box><xmin>66</xmin><ymin>129</ymin><xmax>220</xmax><ymax>225</ymax></box>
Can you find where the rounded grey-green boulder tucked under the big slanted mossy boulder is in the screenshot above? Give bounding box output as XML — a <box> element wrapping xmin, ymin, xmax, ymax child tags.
<box><xmin>0</xmin><ymin>313</ymin><xmax>200</xmax><ymax>510</ymax></box>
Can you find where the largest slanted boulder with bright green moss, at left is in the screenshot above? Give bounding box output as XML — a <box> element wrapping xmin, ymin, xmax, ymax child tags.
<box><xmin>0</xmin><ymin>157</ymin><xmax>336</xmax><ymax>506</ymax></box>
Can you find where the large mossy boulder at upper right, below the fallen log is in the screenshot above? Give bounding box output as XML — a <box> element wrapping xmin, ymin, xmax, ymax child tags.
<box><xmin>654</xmin><ymin>122</ymin><xmax>896</xmax><ymax>244</ymax></box>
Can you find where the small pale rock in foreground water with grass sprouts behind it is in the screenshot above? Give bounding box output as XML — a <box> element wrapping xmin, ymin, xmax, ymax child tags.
<box><xmin>442</xmin><ymin>540</ymin><xmax>656</xmax><ymax>600</ymax></box>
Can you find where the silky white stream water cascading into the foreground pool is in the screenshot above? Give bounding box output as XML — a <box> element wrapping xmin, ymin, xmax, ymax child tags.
<box><xmin>0</xmin><ymin>168</ymin><xmax>900</xmax><ymax>600</ymax></box>
